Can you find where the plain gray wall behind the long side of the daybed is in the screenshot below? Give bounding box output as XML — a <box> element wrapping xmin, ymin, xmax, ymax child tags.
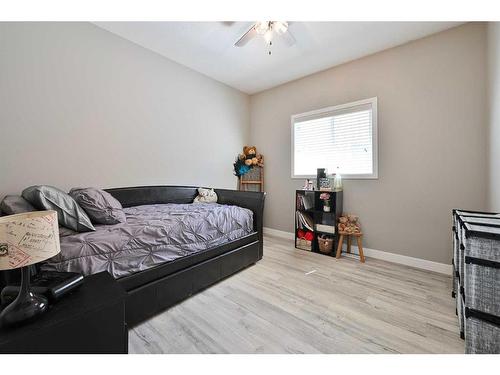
<box><xmin>0</xmin><ymin>23</ymin><xmax>250</xmax><ymax>196</ymax></box>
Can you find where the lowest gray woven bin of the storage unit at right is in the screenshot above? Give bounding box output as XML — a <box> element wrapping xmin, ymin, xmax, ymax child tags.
<box><xmin>465</xmin><ymin>317</ymin><xmax>500</xmax><ymax>354</ymax></box>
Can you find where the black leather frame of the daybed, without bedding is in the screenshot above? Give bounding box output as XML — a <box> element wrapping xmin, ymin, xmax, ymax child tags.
<box><xmin>106</xmin><ymin>186</ymin><xmax>265</xmax><ymax>326</ymax></box>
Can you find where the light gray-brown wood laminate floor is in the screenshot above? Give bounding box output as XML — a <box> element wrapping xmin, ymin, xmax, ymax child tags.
<box><xmin>129</xmin><ymin>236</ymin><xmax>464</xmax><ymax>353</ymax></box>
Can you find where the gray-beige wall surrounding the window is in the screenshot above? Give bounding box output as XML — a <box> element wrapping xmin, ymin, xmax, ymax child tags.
<box><xmin>250</xmin><ymin>24</ymin><xmax>488</xmax><ymax>263</ymax></box>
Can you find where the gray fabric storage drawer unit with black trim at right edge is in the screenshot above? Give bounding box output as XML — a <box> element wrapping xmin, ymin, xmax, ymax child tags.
<box><xmin>453</xmin><ymin>210</ymin><xmax>500</xmax><ymax>353</ymax></box>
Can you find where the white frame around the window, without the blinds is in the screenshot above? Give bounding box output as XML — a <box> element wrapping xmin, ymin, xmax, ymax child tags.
<box><xmin>291</xmin><ymin>97</ymin><xmax>378</xmax><ymax>180</ymax></box>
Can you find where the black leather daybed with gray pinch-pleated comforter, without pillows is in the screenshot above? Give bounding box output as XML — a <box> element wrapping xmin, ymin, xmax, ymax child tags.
<box><xmin>0</xmin><ymin>186</ymin><xmax>265</xmax><ymax>327</ymax></box>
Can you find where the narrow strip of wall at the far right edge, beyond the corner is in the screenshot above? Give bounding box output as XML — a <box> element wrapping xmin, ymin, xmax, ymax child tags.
<box><xmin>488</xmin><ymin>22</ymin><xmax>500</xmax><ymax>212</ymax></box>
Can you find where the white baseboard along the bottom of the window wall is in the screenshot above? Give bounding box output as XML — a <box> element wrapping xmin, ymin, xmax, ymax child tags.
<box><xmin>264</xmin><ymin>227</ymin><xmax>452</xmax><ymax>275</ymax></box>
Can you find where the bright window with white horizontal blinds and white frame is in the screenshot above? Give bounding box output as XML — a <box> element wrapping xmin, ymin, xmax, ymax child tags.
<box><xmin>292</xmin><ymin>98</ymin><xmax>378</xmax><ymax>178</ymax></box>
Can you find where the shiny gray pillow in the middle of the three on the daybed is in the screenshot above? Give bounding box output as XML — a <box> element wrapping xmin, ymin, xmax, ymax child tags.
<box><xmin>22</xmin><ymin>185</ymin><xmax>95</xmax><ymax>232</ymax></box>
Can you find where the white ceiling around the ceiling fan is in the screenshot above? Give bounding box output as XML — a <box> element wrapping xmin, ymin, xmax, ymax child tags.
<box><xmin>95</xmin><ymin>22</ymin><xmax>460</xmax><ymax>94</ymax></box>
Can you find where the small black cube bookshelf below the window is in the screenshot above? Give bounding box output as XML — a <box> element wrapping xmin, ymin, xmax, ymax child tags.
<box><xmin>295</xmin><ymin>190</ymin><xmax>343</xmax><ymax>256</ymax></box>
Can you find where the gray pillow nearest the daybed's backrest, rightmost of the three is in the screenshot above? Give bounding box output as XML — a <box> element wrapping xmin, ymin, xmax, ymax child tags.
<box><xmin>69</xmin><ymin>188</ymin><xmax>127</xmax><ymax>224</ymax></box>
